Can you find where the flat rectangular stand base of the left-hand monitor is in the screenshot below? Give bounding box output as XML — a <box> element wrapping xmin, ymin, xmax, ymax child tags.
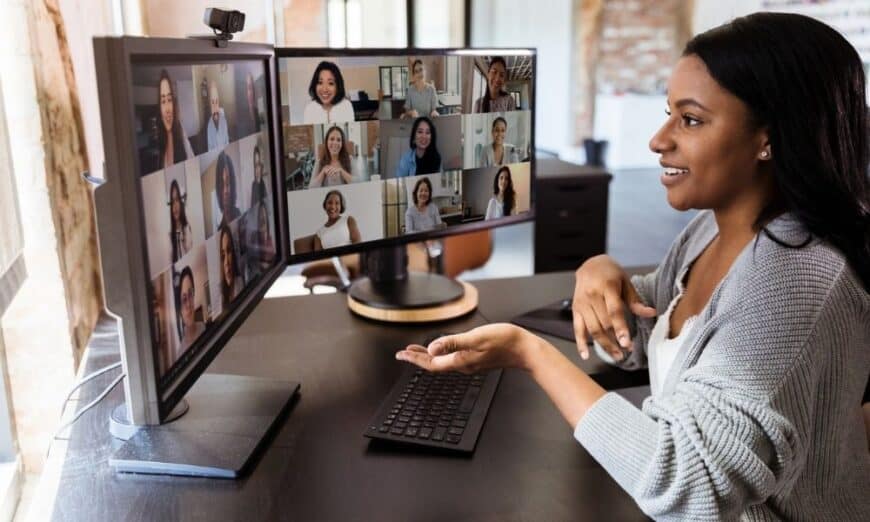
<box><xmin>109</xmin><ymin>373</ymin><xmax>299</xmax><ymax>478</ymax></box>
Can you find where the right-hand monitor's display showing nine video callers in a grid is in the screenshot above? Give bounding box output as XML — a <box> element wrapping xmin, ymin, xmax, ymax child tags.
<box><xmin>276</xmin><ymin>49</ymin><xmax>535</xmax><ymax>263</ymax></box>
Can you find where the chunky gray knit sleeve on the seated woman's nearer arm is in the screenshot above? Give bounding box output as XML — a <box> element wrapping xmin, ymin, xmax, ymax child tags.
<box><xmin>574</xmin><ymin>242</ymin><xmax>862</xmax><ymax>520</ymax></box>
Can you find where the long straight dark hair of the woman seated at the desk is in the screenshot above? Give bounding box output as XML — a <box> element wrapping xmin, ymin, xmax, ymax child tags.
<box><xmin>683</xmin><ymin>13</ymin><xmax>870</xmax><ymax>289</ymax></box>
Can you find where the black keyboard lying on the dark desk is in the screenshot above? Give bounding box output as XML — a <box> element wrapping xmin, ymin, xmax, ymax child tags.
<box><xmin>364</xmin><ymin>365</ymin><xmax>502</xmax><ymax>453</ymax></box>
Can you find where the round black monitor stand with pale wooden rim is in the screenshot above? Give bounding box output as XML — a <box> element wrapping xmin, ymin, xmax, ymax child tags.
<box><xmin>347</xmin><ymin>246</ymin><xmax>477</xmax><ymax>323</ymax></box>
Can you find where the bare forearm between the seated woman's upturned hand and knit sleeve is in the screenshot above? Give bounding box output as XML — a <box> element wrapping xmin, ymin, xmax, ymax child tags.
<box><xmin>524</xmin><ymin>332</ymin><xmax>607</xmax><ymax>429</ymax></box>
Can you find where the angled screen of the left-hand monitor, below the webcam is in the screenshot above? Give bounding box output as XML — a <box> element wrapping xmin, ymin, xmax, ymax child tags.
<box><xmin>131</xmin><ymin>58</ymin><xmax>283</xmax><ymax>388</ymax></box>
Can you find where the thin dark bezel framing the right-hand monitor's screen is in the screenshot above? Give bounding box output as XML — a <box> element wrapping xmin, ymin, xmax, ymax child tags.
<box><xmin>275</xmin><ymin>47</ymin><xmax>537</xmax><ymax>265</ymax></box>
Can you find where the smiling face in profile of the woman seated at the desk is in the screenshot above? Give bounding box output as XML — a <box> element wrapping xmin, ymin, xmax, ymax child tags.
<box><xmin>649</xmin><ymin>55</ymin><xmax>769</xmax><ymax>210</ymax></box>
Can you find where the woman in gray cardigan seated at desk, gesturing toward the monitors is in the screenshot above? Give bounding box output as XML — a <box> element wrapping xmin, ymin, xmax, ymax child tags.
<box><xmin>398</xmin><ymin>13</ymin><xmax>870</xmax><ymax>521</ymax></box>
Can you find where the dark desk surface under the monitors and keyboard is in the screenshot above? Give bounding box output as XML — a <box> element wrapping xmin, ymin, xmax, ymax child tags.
<box><xmin>34</xmin><ymin>272</ymin><xmax>645</xmax><ymax>521</ymax></box>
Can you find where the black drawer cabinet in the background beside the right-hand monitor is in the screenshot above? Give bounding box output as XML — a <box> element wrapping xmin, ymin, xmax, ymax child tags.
<box><xmin>535</xmin><ymin>158</ymin><xmax>612</xmax><ymax>273</ymax></box>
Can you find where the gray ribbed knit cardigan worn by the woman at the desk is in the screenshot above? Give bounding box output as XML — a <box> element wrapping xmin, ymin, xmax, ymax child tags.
<box><xmin>574</xmin><ymin>211</ymin><xmax>870</xmax><ymax>521</ymax></box>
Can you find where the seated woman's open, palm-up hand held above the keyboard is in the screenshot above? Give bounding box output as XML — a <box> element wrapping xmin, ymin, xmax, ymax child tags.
<box><xmin>396</xmin><ymin>323</ymin><xmax>534</xmax><ymax>373</ymax></box>
